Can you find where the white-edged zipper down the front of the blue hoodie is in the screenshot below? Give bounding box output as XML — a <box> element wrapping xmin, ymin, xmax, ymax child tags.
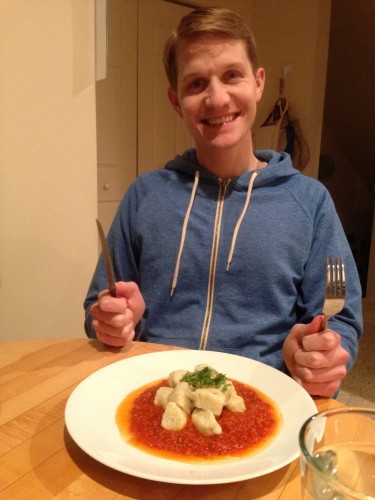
<box><xmin>199</xmin><ymin>179</ymin><xmax>230</xmax><ymax>350</ymax></box>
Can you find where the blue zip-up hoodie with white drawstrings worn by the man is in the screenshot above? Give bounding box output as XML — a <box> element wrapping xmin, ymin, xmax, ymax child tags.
<box><xmin>84</xmin><ymin>149</ymin><xmax>362</xmax><ymax>370</ymax></box>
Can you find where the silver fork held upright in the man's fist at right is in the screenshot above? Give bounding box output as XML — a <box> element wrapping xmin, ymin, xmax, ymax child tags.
<box><xmin>321</xmin><ymin>257</ymin><xmax>345</xmax><ymax>330</ymax></box>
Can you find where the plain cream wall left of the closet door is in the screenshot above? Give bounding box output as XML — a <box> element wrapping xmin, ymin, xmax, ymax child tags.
<box><xmin>0</xmin><ymin>0</ymin><xmax>97</xmax><ymax>341</ymax></box>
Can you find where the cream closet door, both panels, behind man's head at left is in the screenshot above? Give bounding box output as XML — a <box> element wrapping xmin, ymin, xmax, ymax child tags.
<box><xmin>96</xmin><ymin>0</ymin><xmax>192</xmax><ymax>233</ymax></box>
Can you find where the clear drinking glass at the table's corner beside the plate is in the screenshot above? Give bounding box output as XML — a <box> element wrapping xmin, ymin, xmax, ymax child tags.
<box><xmin>299</xmin><ymin>407</ymin><xmax>375</xmax><ymax>500</ymax></box>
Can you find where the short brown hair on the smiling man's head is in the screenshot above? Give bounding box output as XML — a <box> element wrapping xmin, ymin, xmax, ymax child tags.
<box><xmin>163</xmin><ymin>7</ymin><xmax>259</xmax><ymax>90</ymax></box>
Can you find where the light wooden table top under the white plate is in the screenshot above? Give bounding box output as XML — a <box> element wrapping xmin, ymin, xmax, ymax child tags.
<box><xmin>0</xmin><ymin>338</ymin><xmax>342</xmax><ymax>500</ymax></box>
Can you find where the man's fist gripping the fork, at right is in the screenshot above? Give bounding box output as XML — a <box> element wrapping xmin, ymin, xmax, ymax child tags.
<box><xmin>283</xmin><ymin>316</ymin><xmax>349</xmax><ymax>397</ymax></box>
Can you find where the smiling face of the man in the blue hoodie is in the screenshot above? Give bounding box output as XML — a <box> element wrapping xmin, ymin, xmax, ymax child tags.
<box><xmin>168</xmin><ymin>35</ymin><xmax>264</xmax><ymax>157</ymax></box>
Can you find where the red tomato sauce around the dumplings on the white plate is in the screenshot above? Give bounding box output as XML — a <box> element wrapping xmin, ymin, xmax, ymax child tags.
<box><xmin>116</xmin><ymin>380</ymin><xmax>281</xmax><ymax>462</ymax></box>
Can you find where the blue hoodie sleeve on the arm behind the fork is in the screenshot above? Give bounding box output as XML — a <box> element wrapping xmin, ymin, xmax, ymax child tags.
<box><xmin>297</xmin><ymin>189</ymin><xmax>363</xmax><ymax>370</ymax></box>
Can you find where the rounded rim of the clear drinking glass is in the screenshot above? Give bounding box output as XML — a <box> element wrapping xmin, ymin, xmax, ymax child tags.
<box><xmin>298</xmin><ymin>406</ymin><xmax>375</xmax><ymax>499</ymax></box>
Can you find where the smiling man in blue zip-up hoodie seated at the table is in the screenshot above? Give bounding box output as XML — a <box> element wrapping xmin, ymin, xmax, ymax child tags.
<box><xmin>85</xmin><ymin>8</ymin><xmax>362</xmax><ymax>396</ymax></box>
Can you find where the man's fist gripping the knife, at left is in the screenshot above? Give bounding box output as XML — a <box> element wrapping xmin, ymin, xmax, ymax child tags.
<box><xmin>90</xmin><ymin>281</ymin><xmax>145</xmax><ymax>347</ymax></box>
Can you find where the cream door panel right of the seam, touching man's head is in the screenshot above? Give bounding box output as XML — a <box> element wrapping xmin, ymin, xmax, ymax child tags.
<box><xmin>138</xmin><ymin>0</ymin><xmax>193</xmax><ymax>174</ymax></box>
